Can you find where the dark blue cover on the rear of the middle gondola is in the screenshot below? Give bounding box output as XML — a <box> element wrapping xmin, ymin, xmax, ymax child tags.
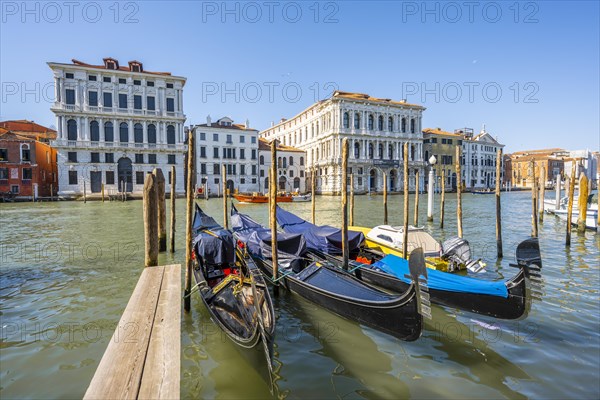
<box><xmin>231</xmin><ymin>208</ymin><xmax>306</xmax><ymax>268</ymax></box>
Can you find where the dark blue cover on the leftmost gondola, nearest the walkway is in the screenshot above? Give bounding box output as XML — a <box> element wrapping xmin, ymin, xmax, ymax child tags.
<box><xmin>192</xmin><ymin>205</ymin><xmax>235</xmax><ymax>265</ymax></box>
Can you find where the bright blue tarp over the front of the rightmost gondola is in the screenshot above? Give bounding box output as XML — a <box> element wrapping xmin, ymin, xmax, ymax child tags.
<box><xmin>371</xmin><ymin>254</ymin><xmax>508</xmax><ymax>298</ymax></box>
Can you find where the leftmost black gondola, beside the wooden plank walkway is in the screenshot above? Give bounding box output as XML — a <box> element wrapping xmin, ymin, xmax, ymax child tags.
<box><xmin>192</xmin><ymin>204</ymin><xmax>275</xmax><ymax>383</ymax></box>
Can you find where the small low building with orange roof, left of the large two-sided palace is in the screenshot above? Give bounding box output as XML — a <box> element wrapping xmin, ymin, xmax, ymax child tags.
<box><xmin>258</xmin><ymin>138</ymin><xmax>307</xmax><ymax>193</ymax></box>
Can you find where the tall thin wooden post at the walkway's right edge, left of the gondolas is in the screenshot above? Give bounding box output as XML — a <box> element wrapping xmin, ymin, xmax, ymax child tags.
<box><xmin>183</xmin><ymin>129</ymin><xmax>196</xmax><ymax>312</ymax></box>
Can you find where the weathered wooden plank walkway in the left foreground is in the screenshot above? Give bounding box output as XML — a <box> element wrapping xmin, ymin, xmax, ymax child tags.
<box><xmin>84</xmin><ymin>264</ymin><xmax>182</xmax><ymax>399</ymax></box>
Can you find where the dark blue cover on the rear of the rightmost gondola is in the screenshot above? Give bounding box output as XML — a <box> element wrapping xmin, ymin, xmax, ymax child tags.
<box><xmin>277</xmin><ymin>207</ymin><xmax>365</xmax><ymax>254</ymax></box>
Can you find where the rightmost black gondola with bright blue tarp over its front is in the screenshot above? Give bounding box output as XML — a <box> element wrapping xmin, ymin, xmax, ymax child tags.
<box><xmin>277</xmin><ymin>209</ymin><xmax>542</xmax><ymax>319</ymax></box>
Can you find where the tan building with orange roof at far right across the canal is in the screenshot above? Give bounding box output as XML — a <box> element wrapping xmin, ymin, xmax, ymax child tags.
<box><xmin>505</xmin><ymin>148</ymin><xmax>569</xmax><ymax>188</ymax></box>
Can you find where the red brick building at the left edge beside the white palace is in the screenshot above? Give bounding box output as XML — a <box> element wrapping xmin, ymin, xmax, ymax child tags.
<box><xmin>0</xmin><ymin>121</ymin><xmax>58</xmax><ymax>199</ymax></box>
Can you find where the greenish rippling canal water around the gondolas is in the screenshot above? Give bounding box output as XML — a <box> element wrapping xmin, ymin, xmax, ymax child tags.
<box><xmin>0</xmin><ymin>192</ymin><xmax>600</xmax><ymax>399</ymax></box>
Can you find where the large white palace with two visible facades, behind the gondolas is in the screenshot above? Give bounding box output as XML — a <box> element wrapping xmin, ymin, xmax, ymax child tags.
<box><xmin>260</xmin><ymin>91</ymin><xmax>425</xmax><ymax>194</ymax></box>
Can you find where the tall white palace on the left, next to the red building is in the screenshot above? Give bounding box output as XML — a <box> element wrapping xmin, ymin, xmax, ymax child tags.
<box><xmin>48</xmin><ymin>58</ymin><xmax>186</xmax><ymax>197</ymax></box>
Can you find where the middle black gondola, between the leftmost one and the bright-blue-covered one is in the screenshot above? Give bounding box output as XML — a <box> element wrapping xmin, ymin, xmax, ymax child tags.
<box><xmin>231</xmin><ymin>207</ymin><xmax>424</xmax><ymax>341</ymax></box>
